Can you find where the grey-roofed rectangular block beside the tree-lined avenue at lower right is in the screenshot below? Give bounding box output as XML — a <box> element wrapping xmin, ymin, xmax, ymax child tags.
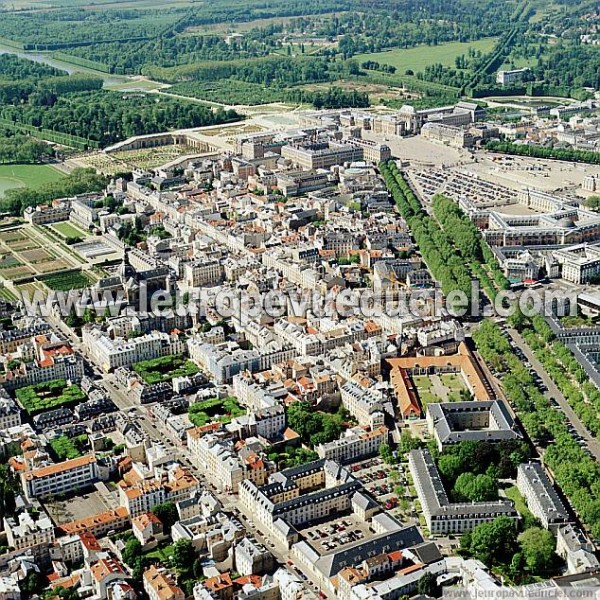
<box><xmin>517</xmin><ymin>462</ymin><xmax>571</xmax><ymax>531</ymax></box>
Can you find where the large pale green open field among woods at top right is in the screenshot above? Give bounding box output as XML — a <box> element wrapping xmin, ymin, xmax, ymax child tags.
<box><xmin>354</xmin><ymin>38</ymin><xmax>496</xmax><ymax>75</ymax></box>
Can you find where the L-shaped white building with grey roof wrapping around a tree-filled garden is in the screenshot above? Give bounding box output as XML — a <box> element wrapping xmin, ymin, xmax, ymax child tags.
<box><xmin>408</xmin><ymin>450</ymin><xmax>519</xmax><ymax>535</ymax></box>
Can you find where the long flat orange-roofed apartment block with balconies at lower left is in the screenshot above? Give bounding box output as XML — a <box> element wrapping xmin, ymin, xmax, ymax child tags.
<box><xmin>21</xmin><ymin>454</ymin><xmax>99</xmax><ymax>500</ymax></box>
